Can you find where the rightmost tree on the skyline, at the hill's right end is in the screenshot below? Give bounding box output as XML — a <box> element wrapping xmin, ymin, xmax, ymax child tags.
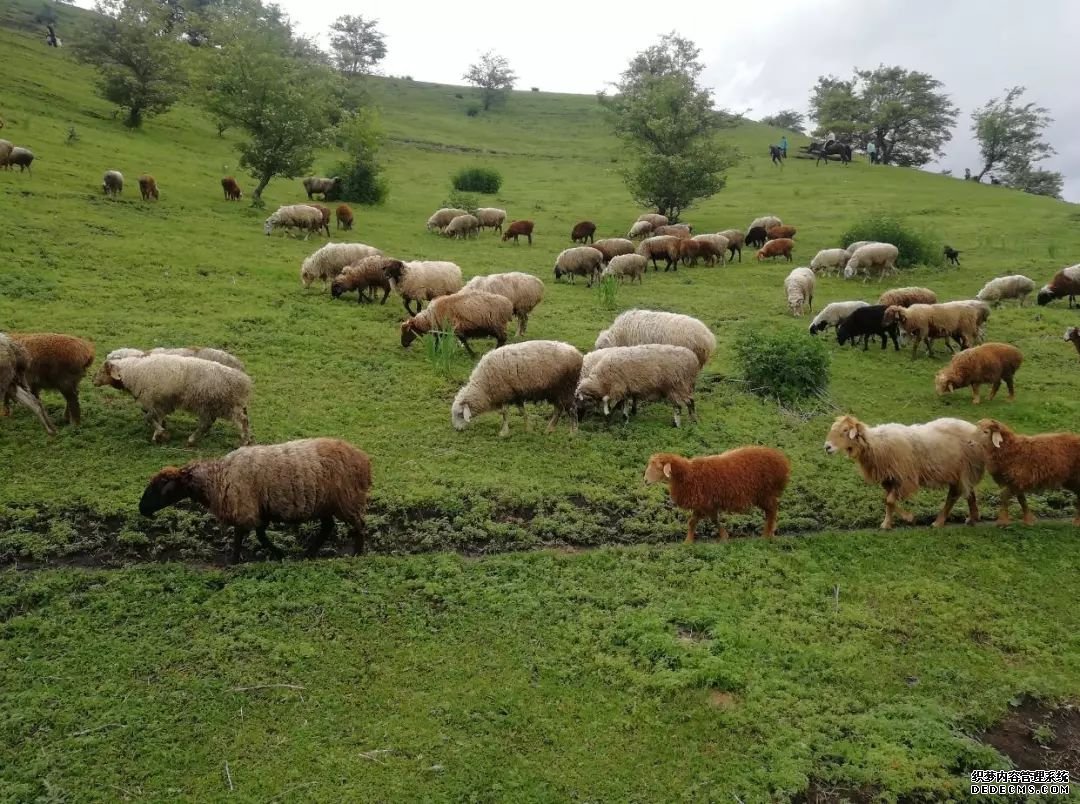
<box><xmin>971</xmin><ymin>86</ymin><xmax>1054</xmax><ymax>184</ymax></box>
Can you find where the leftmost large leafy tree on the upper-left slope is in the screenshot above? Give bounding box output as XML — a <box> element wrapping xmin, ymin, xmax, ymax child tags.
<box><xmin>75</xmin><ymin>0</ymin><xmax>186</xmax><ymax>129</ymax></box>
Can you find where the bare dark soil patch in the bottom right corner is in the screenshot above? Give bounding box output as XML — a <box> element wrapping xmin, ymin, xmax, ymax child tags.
<box><xmin>978</xmin><ymin>698</ymin><xmax>1080</xmax><ymax>778</ymax></box>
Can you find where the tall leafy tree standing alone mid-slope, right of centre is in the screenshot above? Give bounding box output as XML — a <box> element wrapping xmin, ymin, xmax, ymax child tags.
<box><xmin>599</xmin><ymin>32</ymin><xmax>734</xmax><ymax>219</ymax></box>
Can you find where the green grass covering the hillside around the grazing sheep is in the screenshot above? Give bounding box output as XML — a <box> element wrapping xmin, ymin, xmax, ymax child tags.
<box><xmin>0</xmin><ymin>17</ymin><xmax>1080</xmax><ymax>802</ymax></box>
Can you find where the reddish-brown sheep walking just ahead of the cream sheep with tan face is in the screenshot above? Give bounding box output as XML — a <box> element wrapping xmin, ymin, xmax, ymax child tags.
<box><xmin>645</xmin><ymin>446</ymin><xmax>792</xmax><ymax>544</ymax></box>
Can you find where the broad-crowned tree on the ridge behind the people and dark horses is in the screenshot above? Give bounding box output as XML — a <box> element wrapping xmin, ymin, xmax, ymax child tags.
<box><xmin>810</xmin><ymin>65</ymin><xmax>957</xmax><ymax>168</ymax></box>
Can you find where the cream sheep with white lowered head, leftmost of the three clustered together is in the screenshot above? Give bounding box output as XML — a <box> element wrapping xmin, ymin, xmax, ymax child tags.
<box><xmin>450</xmin><ymin>340</ymin><xmax>581</xmax><ymax>438</ymax></box>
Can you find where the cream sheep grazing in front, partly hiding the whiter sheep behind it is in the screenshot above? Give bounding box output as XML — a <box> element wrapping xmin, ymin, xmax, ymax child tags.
<box><xmin>573</xmin><ymin>344</ymin><xmax>701</xmax><ymax>427</ymax></box>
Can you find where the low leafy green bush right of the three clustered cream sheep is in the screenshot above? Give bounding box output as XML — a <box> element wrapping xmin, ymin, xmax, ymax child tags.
<box><xmin>734</xmin><ymin>327</ymin><xmax>828</xmax><ymax>405</ymax></box>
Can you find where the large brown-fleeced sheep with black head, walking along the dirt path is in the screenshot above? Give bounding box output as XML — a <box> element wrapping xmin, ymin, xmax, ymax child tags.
<box><xmin>138</xmin><ymin>439</ymin><xmax>372</xmax><ymax>564</ymax></box>
